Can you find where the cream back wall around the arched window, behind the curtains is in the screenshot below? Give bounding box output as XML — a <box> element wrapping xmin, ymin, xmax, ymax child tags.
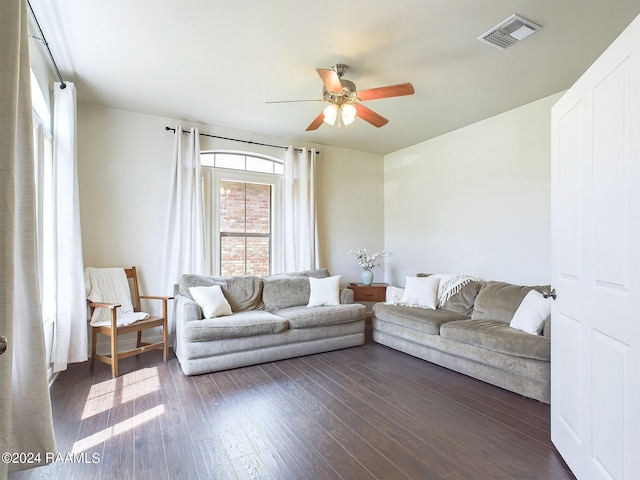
<box><xmin>78</xmin><ymin>104</ymin><xmax>384</xmax><ymax>302</ymax></box>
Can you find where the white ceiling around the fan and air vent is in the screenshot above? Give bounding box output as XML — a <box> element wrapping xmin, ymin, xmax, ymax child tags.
<box><xmin>31</xmin><ymin>0</ymin><xmax>640</xmax><ymax>154</ymax></box>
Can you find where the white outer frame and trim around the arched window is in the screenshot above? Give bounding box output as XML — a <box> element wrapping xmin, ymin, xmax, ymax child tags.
<box><xmin>201</xmin><ymin>150</ymin><xmax>284</xmax><ymax>275</ymax></box>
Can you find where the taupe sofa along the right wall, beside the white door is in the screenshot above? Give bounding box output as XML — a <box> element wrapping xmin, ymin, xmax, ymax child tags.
<box><xmin>373</xmin><ymin>280</ymin><xmax>551</xmax><ymax>403</ymax></box>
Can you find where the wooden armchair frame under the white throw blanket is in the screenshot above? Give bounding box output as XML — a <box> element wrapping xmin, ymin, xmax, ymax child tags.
<box><xmin>89</xmin><ymin>267</ymin><xmax>173</xmax><ymax>378</ymax></box>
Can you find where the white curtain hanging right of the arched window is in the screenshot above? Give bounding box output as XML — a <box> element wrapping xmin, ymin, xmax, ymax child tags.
<box><xmin>283</xmin><ymin>145</ymin><xmax>320</xmax><ymax>272</ymax></box>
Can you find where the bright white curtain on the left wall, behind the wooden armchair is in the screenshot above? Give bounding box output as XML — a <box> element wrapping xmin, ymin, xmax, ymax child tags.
<box><xmin>51</xmin><ymin>82</ymin><xmax>87</xmax><ymax>372</ymax></box>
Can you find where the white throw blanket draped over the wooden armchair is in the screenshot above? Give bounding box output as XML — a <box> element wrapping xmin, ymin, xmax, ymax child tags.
<box><xmin>84</xmin><ymin>267</ymin><xmax>149</xmax><ymax>327</ymax></box>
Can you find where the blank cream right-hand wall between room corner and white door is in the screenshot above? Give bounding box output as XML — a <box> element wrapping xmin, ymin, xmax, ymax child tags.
<box><xmin>384</xmin><ymin>94</ymin><xmax>560</xmax><ymax>286</ymax></box>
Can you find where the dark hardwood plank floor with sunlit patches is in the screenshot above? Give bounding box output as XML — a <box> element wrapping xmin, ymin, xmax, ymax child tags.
<box><xmin>9</xmin><ymin>330</ymin><xmax>574</xmax><ymax>480</ymax></box>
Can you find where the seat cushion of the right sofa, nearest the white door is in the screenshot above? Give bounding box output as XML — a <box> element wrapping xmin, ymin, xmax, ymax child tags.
<box><xmin>440</xmin><ymin>320</ymin><xmax>551</xmax><ymax>362</ymax></box>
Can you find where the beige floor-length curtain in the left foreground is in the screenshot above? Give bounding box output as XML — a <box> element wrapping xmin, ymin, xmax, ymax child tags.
<box><xmin>0</xmin><ymin>0</ymin><xmax>55</xmax><ymax>479</ymax></box>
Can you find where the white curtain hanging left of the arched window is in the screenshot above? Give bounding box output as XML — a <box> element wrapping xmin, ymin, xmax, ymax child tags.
<box><xmin>162</xmin><ymin>126</ymin><xmax>206</xmax><ymax>332</ymax></box>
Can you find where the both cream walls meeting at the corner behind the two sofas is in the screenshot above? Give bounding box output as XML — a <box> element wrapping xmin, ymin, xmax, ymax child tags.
<box><xmin>78</xmin><ymin>90</ymin><xmax>559</xmax><ymax>306</ymax></box>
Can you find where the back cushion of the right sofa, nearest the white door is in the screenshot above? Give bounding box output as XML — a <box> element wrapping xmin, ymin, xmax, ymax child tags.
<box><xmin>471</xmin><ymin>281</ymin><xmax>549</xmax><ymax>323</ymax></box>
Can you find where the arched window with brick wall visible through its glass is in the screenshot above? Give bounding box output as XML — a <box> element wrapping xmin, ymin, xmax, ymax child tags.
<box><xmin>200</xmin><ymin>151</ymin><xmax>283</xmax><ymax>275</ymax></box>
